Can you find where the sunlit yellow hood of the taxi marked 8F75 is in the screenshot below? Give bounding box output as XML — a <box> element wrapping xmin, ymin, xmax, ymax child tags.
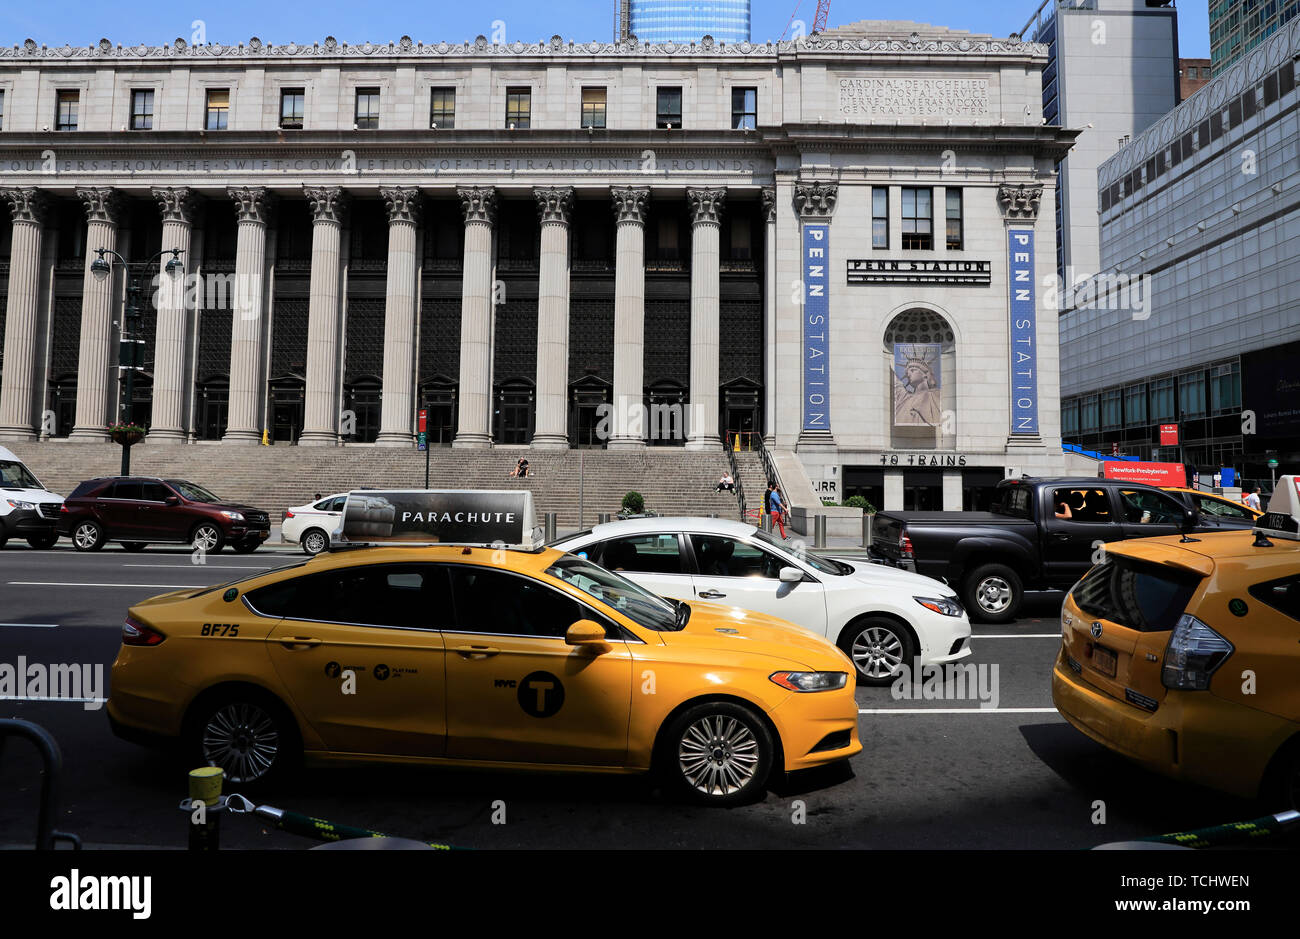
<box><xmin>659</xmin><ymin>601</ymin><xmax>853</xmax><ymax>675</ymax></box>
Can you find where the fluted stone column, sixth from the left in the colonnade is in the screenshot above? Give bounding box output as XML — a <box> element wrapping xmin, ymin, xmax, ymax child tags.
<box><xmin>376</xmin><ymin>186</ymin><xmax>423</xmax><ymax>447</ymax></box>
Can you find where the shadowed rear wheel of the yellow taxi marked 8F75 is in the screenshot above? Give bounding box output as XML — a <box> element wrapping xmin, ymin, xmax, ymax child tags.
<box><xmin>187</xmin><ymin>688</ymin><xmax>300</xmax><ymax>788</ymax></box>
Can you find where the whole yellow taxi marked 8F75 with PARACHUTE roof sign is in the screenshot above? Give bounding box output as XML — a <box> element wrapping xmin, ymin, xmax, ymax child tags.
<box><xmin>108</xmin><ymin>490</ymin><xmax>862</xmax><ymax>805</ymax></box>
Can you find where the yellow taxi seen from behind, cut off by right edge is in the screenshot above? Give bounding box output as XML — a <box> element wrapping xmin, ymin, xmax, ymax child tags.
<box><xmin>1052</xmin><ymin>476</ymin><xmax>1300</xmax><ymax>809</ymax></box>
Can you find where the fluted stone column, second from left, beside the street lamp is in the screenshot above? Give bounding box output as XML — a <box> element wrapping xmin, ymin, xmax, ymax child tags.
<box><xmin>69</xmin><ymin>187</ymin><xmax>122</xmax><ymax>442</ymax></box>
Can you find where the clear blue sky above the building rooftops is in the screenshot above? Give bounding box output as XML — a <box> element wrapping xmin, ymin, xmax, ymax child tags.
<box><xmin>0</xmin><ymin>0</ymin><xmax>1209</xmax><ymax>57</ymax></box>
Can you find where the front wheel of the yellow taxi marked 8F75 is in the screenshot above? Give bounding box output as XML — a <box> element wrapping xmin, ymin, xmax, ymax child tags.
<box><xmin>659</xmin><ymin>701</ymin><xmax>775</xmax><ymax>805</ymax></box>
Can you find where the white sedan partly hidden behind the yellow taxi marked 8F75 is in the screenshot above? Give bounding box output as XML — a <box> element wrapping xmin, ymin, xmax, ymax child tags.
<box><xmin>555</xmin><ymin>518</ymin><xmax>971</xmax><ymax>685</ymax></box>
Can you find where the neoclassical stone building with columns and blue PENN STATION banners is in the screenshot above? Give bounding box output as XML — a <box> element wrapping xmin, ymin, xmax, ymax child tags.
<box><xmin>0</xmin><ymin>22</ymin><xmax>1074</xmax><ymax>507</ymax></box>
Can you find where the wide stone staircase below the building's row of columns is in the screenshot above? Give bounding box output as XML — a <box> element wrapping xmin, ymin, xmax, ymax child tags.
<box><xmin>4</xmin><ymin>441</ymin><xmax>764</xmax><ymax>529</ymax></box>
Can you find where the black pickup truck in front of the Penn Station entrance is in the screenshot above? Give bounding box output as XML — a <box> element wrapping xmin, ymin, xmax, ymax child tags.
<box><xmin>868</xmin><ymin>476</ymin><xmax>1253</xmax><ymax>623</ymax></box>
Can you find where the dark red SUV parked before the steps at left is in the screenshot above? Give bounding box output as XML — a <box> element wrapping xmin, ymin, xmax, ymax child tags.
<box><xmin>59</xmin><ymin>476</ymin><xmax>270</xmax><ymax>554</ymax></box>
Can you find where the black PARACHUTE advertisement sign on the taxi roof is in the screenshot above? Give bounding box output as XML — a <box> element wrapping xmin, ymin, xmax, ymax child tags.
<box><xmin>335</xmin><ymin>489</ymin><xmax>541</xmax><ymax>548</ymax></box>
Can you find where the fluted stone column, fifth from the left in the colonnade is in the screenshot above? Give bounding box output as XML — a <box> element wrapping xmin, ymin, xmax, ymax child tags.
<box><xmin>298</xmin><ymin>186</ymin><xmax>347</xmax><ymax>446</ymax></box>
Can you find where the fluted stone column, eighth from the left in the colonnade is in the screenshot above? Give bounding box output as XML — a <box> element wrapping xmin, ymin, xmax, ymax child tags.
<box><xmin>533</xmin><ymin>186</ymin><xmax>573</xmax><ymax>450</ymax></box>
